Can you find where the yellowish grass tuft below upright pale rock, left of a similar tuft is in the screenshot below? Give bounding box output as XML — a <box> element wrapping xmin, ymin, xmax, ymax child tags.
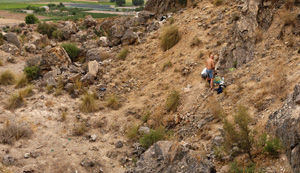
<box><xmin>79</xmin><ymin>94</ymin><xmax>97</xmax><ymax>113</ymax></box>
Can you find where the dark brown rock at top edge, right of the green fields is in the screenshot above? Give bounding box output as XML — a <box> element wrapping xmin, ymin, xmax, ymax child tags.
<box><xmin>145</xmin><ymin>0</ymin><xmax>186</xmax><ymax>15</ymax></box>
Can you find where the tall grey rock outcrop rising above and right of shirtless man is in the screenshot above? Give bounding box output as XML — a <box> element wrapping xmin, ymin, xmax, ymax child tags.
<box><xmin>216</xmin><ymin>0</ymin><xmax>272</xmax><ymax>70</ymax></box>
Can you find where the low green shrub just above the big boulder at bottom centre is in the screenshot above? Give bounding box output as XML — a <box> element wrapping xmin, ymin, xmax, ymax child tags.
<box><xmin>140</xmin><ymin>126</ymin><xmax>165</xmax><ymax>149</ymax></box>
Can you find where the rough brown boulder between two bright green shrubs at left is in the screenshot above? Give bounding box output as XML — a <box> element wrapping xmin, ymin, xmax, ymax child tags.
<box><xmin>40</xmin><ymin>47</ymin><xmax>72</xmax><ymax>71</ymax></box>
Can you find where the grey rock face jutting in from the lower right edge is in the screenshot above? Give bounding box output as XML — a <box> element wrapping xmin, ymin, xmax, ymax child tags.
<box><xmin>267</xmin><ymin>83</ymin><xmax>300</xmax><ymax>172</ymax></box>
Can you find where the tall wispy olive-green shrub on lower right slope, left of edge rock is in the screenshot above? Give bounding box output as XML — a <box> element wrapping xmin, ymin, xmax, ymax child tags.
<box><xmin>224</xmin><ymin>105</ymin><xmax>255</xmax><ymax>162</ymax></box>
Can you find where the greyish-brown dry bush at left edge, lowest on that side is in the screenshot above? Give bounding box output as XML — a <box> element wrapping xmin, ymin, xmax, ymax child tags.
<box><xmin>0</xmin><ymin>122</ymin><xmax>33</xmax><ymax>145</ymax></box>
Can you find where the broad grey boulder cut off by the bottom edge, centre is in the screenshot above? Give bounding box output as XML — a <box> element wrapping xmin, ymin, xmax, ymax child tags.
<box><xmin>134</xmin><ymin>141</ymin><xmax>216</xmax><ymax>173</ymax></box>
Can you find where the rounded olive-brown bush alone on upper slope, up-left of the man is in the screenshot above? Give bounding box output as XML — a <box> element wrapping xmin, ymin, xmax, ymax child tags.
<box><xmin>160</xmin><ymin>25</ymin><xmax>180</xmax><ymax>51</ymax></box>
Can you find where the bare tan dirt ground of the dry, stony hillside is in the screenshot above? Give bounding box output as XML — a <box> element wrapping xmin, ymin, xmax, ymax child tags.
<box><xmin>0</xmin><ymin>1</ymin><xmax>300</xmax><ymax>172</ymax></box>
